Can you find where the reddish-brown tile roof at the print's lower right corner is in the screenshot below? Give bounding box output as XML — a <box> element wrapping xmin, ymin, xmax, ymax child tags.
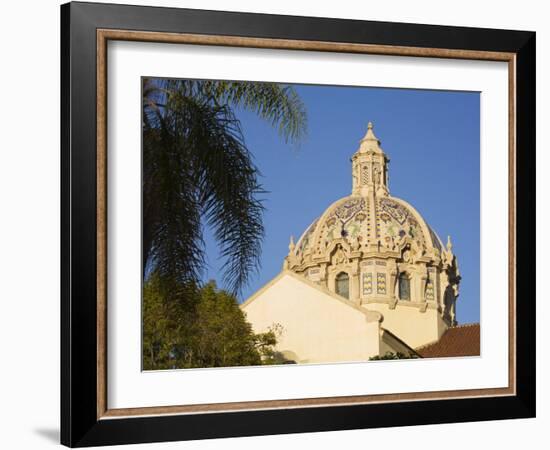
<box><xmin>415</xmin><ymin>323</ymin><xmax>480</xmax><ymax>358</ymax></box>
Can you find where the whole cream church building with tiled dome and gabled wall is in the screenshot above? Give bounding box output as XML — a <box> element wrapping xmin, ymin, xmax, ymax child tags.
<box><xmin>241</xmin><ymin>122</ymin><xmax>479</xmax><ymax>364</ymax></box>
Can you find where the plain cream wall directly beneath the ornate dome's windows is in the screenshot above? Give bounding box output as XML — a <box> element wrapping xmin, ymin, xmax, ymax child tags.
<box><xmin>365</xmin><ymin>302</ymin><xmax>447</xmax><ymax>348</ymax></box>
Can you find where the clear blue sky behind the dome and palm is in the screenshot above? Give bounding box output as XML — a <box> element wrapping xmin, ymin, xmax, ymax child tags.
<box><xmin>204</xmin><ymin>85</ymin><xmax>480</xmax><ymax>323</ymax></box>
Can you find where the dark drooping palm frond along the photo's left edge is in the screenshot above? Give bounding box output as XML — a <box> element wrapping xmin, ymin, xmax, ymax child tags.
<box><xmin>143</xmin><ymin>92</ymin><xmax>204</xmax><ymax>292</ymax></box>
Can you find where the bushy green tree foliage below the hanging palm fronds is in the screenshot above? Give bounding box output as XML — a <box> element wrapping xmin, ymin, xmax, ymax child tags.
<box><xmin>143</xmin><ymin>272</ymin><xmax>282</xmax><ymax>370</ymax></box>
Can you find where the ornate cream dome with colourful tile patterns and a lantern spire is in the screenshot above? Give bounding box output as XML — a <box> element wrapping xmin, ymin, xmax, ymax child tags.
<box><xmin>285</xmin><ymin>123</ymin><xmax>460</xmax><ymax>325</ymax></box>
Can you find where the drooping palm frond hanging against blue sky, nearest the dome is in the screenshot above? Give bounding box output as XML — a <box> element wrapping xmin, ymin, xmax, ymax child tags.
<box><xmin>170</xmin><ymin>92</ymin><xmax>270</xmax><ymax>293</ymax></box>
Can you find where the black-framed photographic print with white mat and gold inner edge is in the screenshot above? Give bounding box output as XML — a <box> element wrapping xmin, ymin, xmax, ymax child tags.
<box><xmin>61</xmin><ymin>3</ymin><xmax>535</xmax><ymax>446</ymax></box>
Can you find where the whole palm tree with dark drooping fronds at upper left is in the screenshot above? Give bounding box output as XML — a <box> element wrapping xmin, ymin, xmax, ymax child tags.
<box><xmin>142</xmin><ymin>79</ymin><xmax>306</xmax><ymax>294</ymax></box>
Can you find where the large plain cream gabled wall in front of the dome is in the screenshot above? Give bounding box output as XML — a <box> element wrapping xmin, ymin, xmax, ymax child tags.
<box><xmin>242</xmin><ymin>272</ymin><xmax>380</xmax><ymax>363</ymax></box>
